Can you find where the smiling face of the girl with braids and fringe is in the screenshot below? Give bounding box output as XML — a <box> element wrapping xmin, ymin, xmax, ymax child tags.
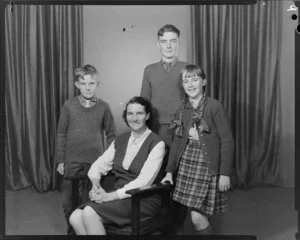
<box><xmin>182</xmin><ymin>72</ymin><xmax>206</xmax><ymax>99</ymax></box>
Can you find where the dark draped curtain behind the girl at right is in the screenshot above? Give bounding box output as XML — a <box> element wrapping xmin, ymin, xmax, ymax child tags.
<box><xmin>192</xmin><ymin>1</ymin><xmax>283</xmax><ymax>188</ymax></box>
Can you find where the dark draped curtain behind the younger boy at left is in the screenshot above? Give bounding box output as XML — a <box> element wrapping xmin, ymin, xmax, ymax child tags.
<box><xmin>5</xmin><ymin>5</ymin><xmax>83</xmax><ymax>192</ymax></box>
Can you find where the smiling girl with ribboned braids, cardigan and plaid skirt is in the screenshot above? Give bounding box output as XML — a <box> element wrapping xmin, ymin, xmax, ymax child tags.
<box><xmin>162</xmin><ymin>65</ymin><xmax>234</xmax><ymax>234</ymax></box>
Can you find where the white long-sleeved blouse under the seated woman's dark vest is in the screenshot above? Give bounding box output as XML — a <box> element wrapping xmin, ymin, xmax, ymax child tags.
<box><xmin>88</xmin><ymin>128</ymin><xmax>165</xmax><ymax>199</ymax></box>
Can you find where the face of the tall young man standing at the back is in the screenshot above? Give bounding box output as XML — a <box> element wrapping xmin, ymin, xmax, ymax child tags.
<box><xmin>157</xmin><ymin>32</ymin><xmax>179</xmax><ymax>60</ymax></box>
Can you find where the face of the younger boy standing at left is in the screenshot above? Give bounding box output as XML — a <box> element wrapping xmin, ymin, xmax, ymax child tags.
<box><xmin>75</xmin><ymin>74</ymin><xmax>99</xmax><ymax>100</ymax></box>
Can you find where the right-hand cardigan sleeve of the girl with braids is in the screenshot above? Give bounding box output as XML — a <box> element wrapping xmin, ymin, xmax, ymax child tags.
<box><xmin>213</xmin><ymin>104</ymin><xmax>234</xmax><ymax>176</ymax></box>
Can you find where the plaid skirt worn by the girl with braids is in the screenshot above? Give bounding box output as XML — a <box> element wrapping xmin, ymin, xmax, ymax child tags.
<box><xmin>173</xmin><ymin>140</ymin><xmax>228</xmax><ymax>215</ymax></box>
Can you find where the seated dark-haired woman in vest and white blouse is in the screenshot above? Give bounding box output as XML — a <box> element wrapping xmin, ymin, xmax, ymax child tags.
<box><xmin>69</xmin><ymin>97</ymin><xmax>165</xmax><ymax>235</ymax></box>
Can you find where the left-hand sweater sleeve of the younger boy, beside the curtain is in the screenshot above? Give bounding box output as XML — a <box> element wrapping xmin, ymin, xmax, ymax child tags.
<box><xmin>55</xmin><ymin>103</ymin><xmax>70</xmax><ymax>163</ymax></box>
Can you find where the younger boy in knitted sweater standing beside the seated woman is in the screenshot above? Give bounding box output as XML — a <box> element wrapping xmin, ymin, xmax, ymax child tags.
<box><xmin>56</xmin><ymin>65</ymin><xmax>115</xmax><ymax>234</ymax></box>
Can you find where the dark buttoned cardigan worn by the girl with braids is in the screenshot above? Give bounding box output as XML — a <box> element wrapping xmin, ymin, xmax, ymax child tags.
<box><xmin>166</xmin><ymin>97</ymin><xmax>234</xmax><ymax>176</ymax></box>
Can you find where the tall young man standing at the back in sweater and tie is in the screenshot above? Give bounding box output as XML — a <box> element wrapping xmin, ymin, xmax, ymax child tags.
<box><xmin>141</xmin><ymin>24</ymin><xmax>188</xmax><ymax>147</ymax></box>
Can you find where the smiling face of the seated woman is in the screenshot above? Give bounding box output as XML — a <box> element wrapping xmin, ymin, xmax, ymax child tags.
<box><xmin>126</xmin><ymin>103</ymin><xmax>150</xmax><ymax>133</ymax></box>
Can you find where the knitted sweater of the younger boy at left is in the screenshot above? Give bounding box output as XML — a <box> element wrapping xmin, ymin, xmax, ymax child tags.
<box><xmin>55</xmin><ymin>96</ymin><xmax>115</xmax><ymax>163</ymax></box>
